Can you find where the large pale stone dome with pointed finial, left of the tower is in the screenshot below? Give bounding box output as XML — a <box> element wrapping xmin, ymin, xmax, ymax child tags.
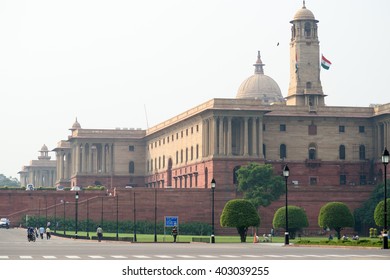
<box><xmin>236</xmin><ymin>52</ymin><xmax>285</xmax><ymax>105</ymax></box>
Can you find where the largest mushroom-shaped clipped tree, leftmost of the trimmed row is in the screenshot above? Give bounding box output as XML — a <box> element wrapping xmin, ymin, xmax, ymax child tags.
<box><xmin>220</xmin><ymin>199</ymin><xmax>260</xmax><ymax>242</ymax></box>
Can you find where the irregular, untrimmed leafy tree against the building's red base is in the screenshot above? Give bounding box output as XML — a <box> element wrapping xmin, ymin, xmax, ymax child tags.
<box><xmin>237</xmin><ymin>163</ymin><xmax>285</xmax><ymax>208</ymax></box>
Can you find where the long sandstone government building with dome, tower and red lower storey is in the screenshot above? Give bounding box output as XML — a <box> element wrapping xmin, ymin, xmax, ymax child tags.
<box><xmin>20</xmin><ymin>3</ymin><xmax>390</xmax><ymax>234</ymax></box>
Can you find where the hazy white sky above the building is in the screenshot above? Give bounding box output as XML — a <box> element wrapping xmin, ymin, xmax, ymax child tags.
<box><xmin>0</xmin><ymin>0</ymin><xmax>390</xmax><ymax>178</ymax></box>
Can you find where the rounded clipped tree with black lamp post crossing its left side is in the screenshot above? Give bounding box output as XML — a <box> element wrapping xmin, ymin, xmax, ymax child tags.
<box><xmin>272</xmin><ymin>205</ymin><xmax>309</xmax><ymax>238</ymax></box>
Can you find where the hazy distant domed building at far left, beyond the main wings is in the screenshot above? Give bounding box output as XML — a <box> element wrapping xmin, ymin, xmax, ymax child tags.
<box><xmin>18</xmin><ymin>145</ymin><xmax>57</xmax><ymax>187</ymax></box>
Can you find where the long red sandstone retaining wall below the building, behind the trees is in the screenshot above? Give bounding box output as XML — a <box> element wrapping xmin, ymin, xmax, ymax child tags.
<box><xmin>0</xmin><ymin>186</ymin><xmax>374</xmax><ymax>234</ymax></box>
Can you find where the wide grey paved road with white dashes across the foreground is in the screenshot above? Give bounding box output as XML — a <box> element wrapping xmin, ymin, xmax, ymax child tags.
<box><xmin>0</xmin><ymin>229</ymin><xmax>390</xmax><ymax>260</ymax></box>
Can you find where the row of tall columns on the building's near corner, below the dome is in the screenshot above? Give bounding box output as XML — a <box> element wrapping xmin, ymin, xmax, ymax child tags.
<box><xmin>202</xmin><ymin>116</ymin><xmax>263</xmax><ymax>158</ymax></box>
